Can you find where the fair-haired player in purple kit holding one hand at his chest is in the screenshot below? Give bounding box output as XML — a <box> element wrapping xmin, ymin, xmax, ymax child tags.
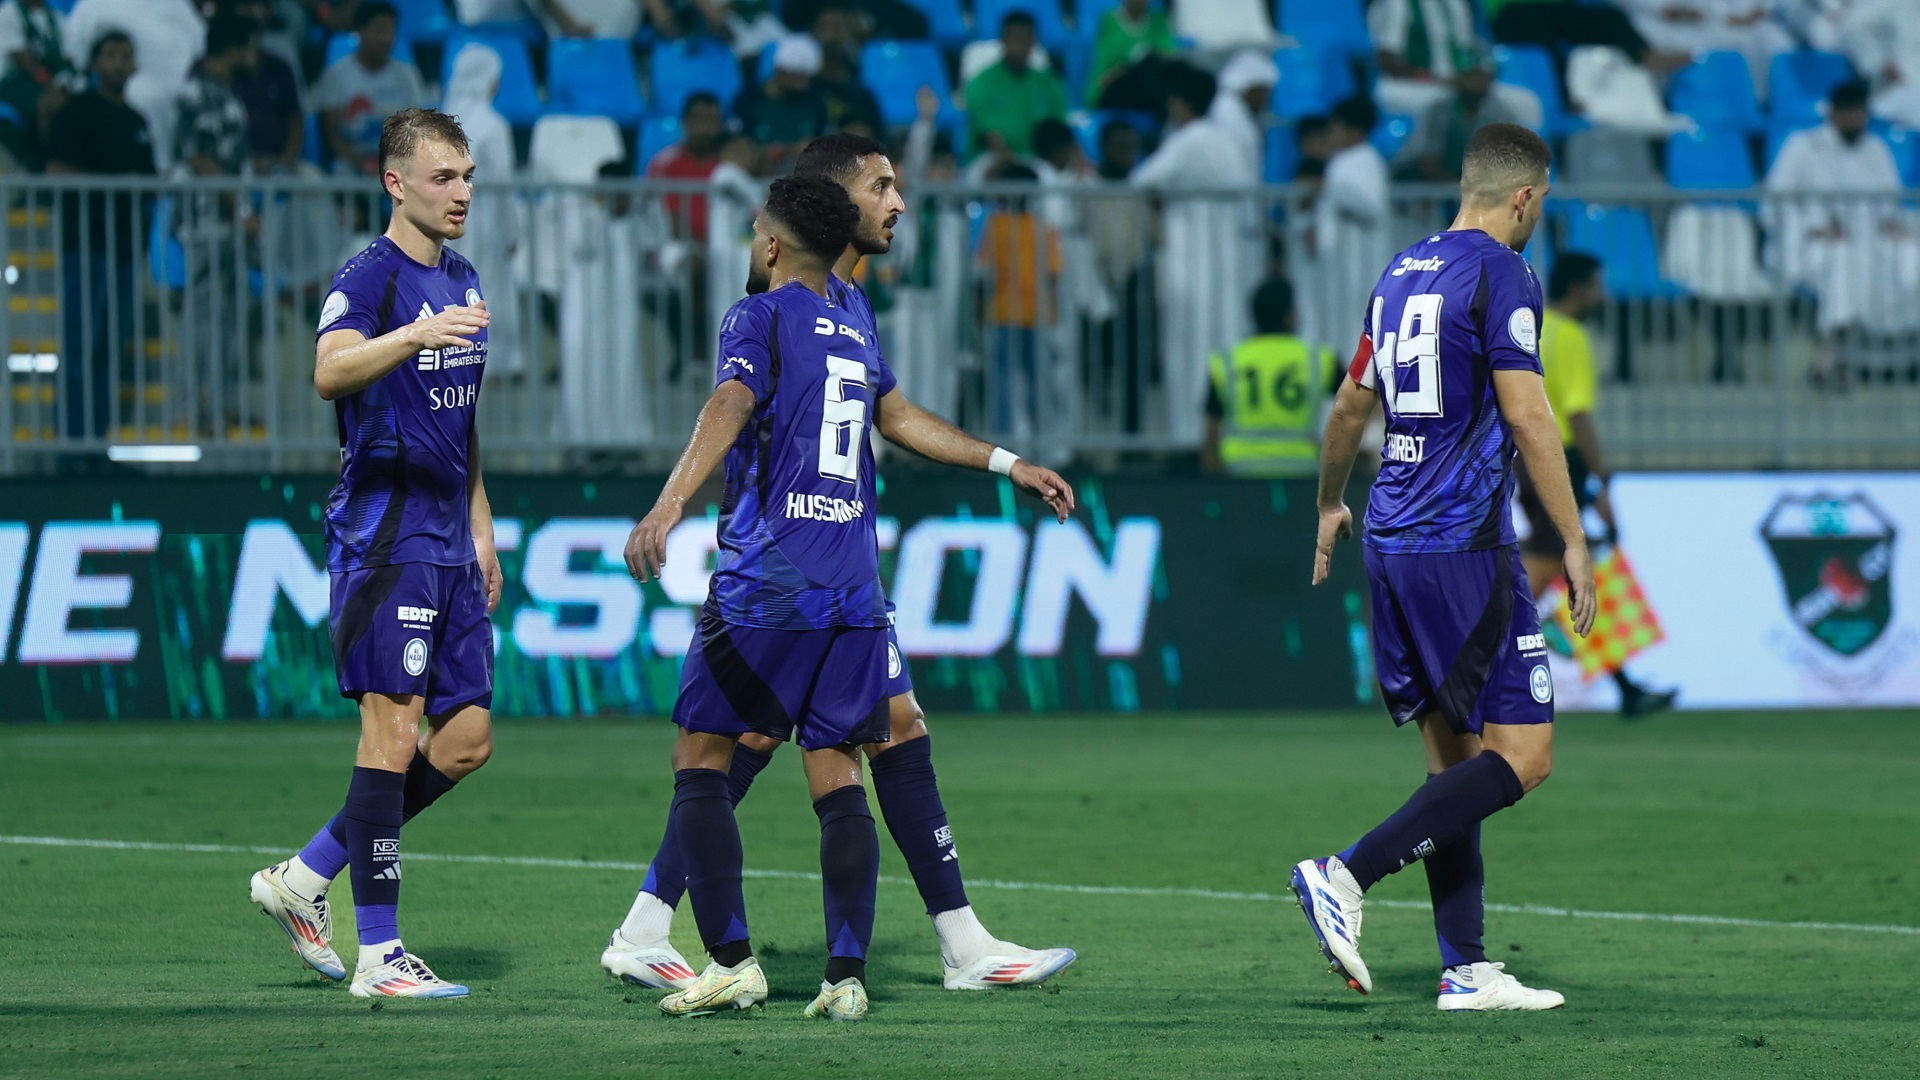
<box><xmin>250</xmin><ymin>110</ymin><xmax>501</xmax><ymax>997</ymax></box>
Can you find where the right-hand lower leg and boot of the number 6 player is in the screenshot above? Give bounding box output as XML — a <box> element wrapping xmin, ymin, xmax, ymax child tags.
<box><xmin>801</xmin><ymin>746</ymin><xmax>879</xmax><ymax>1020</ymax></box>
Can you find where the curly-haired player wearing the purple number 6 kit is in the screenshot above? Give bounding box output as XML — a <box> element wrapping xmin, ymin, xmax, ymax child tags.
<box><xmin>626</xmin><ymin>175</ymin><xmax>1073</xmax><ymax>1020</ymax></box>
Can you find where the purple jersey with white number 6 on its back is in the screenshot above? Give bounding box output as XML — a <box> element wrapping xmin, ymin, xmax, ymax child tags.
<box><xmin>707</xmin><ymin>282</ymin><xmax>895</xmax><ymax>630</ymax></box>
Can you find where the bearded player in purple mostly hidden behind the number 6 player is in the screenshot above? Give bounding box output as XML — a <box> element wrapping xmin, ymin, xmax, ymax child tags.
<box><xmin>601</xmin><ymin>135</ymin><xmax>1075</xmax><ymax>990</ymax></box>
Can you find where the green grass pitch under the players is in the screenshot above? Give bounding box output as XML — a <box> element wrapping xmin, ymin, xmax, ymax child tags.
<box><xmin>0</xmin><ymin>713</ymin><xmax>1920</xmax><ymax>1078</ymax></box>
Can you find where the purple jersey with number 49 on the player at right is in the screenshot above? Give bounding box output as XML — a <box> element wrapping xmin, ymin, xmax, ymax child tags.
<box><xmin>1352</xmin><ymin>229</ymin><xmax>1540</xmax><ymax>553</ymax></box>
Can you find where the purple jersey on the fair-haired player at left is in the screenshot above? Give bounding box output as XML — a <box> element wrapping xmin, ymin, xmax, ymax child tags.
<box><xmin>317</xmin><ymin>236</ymin><xmax>486</xmax><ymax>571</ymax></box>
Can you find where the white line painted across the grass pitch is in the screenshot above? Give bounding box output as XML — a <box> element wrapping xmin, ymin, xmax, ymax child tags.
<box><xmin>11</xmin><ymin>836</ymin><xmax>1920</xmax><ymax>936</ymax></box>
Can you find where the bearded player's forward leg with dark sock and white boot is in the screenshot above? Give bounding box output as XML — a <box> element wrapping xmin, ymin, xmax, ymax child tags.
<box><xmin>866</xmin><ymin>684</ymin><xmax>1075</xmax><ymax>990</ymax></box>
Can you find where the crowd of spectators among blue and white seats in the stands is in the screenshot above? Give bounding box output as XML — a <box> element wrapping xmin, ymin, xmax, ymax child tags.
<box><xmin>15</xmin><ymin>0</ymin><xmax>1920</xmax><ymax>457</ymax></box>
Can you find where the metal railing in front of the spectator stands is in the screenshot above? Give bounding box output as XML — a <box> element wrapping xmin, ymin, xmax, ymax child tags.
<box><xmin>0</xmin><ymin>177</ymin><xmax>1920</xmax><ymax>473</ymax></box>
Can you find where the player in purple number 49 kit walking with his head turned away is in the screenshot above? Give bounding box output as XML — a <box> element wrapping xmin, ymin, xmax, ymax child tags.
<box><xmin>1290</xmin><ymin>123</ymin><xmax>1594</xmax><ymax>1011</ymax></box>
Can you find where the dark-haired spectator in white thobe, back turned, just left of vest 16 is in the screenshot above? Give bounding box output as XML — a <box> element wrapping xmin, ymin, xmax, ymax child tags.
<box><xmin>1133</xmin><ymin>67</ymin><xmax>1258</xmax><ymax>446</ymax></box>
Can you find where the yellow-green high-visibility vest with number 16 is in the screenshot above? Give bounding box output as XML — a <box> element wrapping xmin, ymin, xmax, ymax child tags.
<box><xmin>1210</xmin><ymin>334</ymin><xmax>1334</xmax><ymax>477</ymax></box>
